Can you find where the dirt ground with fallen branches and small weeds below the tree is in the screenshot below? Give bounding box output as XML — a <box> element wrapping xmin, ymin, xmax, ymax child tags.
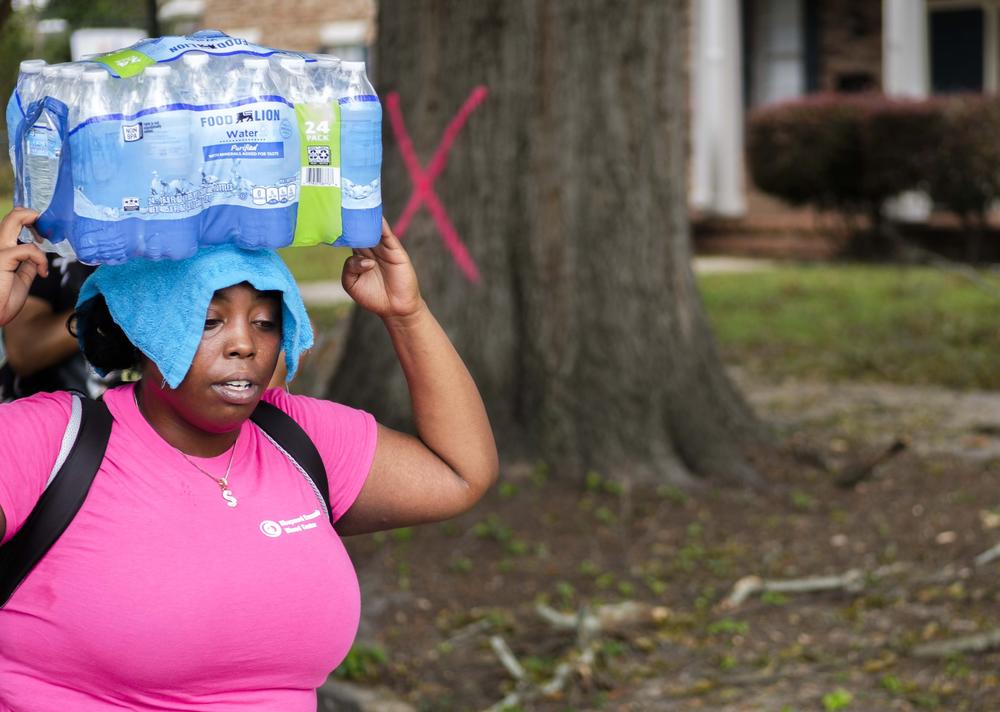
<box><xmin>338</xmin><ymin>373</ymin><xmax>1000</xmax><ymax>712</ymax></box>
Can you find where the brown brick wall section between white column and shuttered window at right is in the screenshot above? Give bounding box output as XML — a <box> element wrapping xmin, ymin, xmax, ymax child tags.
<box><xmin>820</xmin><ymin>0</ymin><xmax>882</xmax><ymax>91</ymax></box>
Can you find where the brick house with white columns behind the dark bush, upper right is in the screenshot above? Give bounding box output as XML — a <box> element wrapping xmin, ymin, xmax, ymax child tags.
<box><xmin>690</xmin><ymin>0</ymin><xmax>1000</xmax><ymax>217</ymax></box>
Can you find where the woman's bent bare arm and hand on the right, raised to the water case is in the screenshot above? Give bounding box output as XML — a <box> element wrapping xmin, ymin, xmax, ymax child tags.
<box><xmin>337</xmin><ymin>223</ymin><xmax>499</xmax><ymax>535</ymax></box>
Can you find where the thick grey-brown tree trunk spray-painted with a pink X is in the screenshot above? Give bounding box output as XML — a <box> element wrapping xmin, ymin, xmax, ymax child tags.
<box><xmin>329</xmin><ymin>0</ymin><xmax>763</xmax><ymax>482</ymax></box>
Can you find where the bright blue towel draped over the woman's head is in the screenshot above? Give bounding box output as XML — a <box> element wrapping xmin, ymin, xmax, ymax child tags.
<box><xmin>76</xmin><ymin>245</ymin><xmax>313</xmax><ymax>388</ymax></box>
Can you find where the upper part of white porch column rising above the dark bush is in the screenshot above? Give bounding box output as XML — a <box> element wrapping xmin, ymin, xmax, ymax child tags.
<box><xmin>882</xmin><ymin>0</ymin><xmax>930</xmax><ymax>99</ymax></box>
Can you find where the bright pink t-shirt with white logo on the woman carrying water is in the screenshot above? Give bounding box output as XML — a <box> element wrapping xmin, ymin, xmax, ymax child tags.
<box><xmin>0</xmin><ymin>386</ymin><xmax>376</xmax><ymax>712</ymax></box>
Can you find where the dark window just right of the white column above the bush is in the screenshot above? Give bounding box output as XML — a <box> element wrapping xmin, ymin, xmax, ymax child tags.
<box><xmin>930</xmin><ymin>9</ymin><xmax>983</xmax><ymax>94</ymax></box>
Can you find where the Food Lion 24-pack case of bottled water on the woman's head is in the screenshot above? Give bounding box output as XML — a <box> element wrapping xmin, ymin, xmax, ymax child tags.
<box><xmin>7</xmin><ymin>30</ymin><xmax>382</xmax><ymax>264</ymax></box>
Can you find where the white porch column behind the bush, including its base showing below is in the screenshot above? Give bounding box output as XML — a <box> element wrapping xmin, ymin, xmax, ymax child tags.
<box><xmin>882</xmin><ymin>0</ymin><xmax>933</xmax><ymax>222</ymax></box>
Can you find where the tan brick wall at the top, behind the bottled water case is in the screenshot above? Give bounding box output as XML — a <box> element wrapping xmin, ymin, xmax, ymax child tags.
<box><xmin>201</xmin><ymin>0</ymin><xmax>375</xmax><ymax>52</ymax></box>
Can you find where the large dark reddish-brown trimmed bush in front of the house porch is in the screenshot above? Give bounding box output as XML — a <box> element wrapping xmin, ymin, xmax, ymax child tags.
<box><xmin>747</xmin><ymin>94</ymin><xmax>964</xmax><ymax>230</ymax></box>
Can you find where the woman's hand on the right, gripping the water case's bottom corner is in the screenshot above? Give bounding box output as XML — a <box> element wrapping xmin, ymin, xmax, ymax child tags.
<box><xmin>340</xmin><ymin>218</ymin><xmax>426</xmax><ymax>319</ymax></box>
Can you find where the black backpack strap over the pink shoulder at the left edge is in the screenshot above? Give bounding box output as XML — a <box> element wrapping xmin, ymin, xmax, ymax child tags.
<box><xmin>0</xmin><ymin>396</ymin><xmax>114</xmax><ymax>607</ymax></box>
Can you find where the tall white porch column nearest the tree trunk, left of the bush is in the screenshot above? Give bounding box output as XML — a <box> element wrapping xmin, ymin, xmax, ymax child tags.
<box><xmin>690</xmin><ymin>0</ymin><xmax>746</xmax><ymax>216</ymax></box>
